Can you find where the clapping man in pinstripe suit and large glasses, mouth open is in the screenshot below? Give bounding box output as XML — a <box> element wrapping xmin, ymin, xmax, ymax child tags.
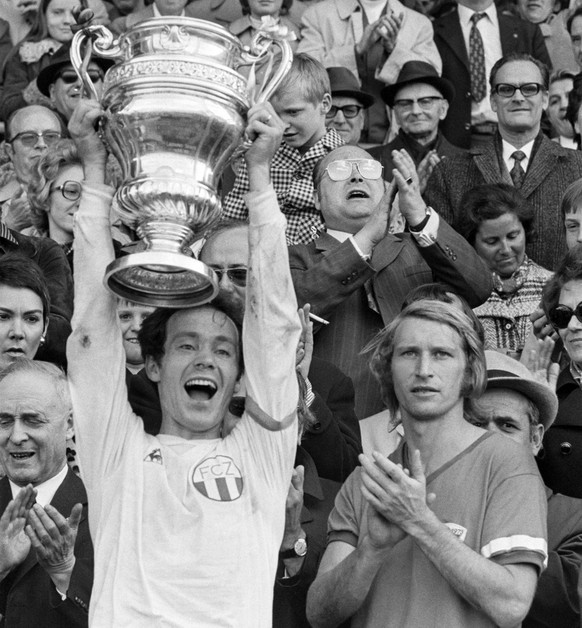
<box><xmin>289</xmin><ymin>146</ymin><xmax>492</xmax><ymax>418</ymax></box>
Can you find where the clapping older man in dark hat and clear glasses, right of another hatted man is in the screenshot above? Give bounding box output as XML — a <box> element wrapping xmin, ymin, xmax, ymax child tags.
<box><xmin>370</xmin><ymin>61</ymin><xmax>464</xmax><ymax>192</ymax></box>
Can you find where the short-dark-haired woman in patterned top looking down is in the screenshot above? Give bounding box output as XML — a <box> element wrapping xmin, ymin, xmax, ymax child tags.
<box><xmin>460</xmin><ymin>183</ymin><xmax>552</xmax><ymax>359</ymax></box>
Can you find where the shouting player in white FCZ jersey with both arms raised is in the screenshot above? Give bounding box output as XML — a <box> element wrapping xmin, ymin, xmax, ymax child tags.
<box><xmin>68</xmin><ymin>102</ymin><xmax>300</xmax><ymax>628</ymax></box>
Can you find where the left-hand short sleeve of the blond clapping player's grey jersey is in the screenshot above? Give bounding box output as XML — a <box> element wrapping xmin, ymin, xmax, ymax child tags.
<box><xmin>327</xmin><ymin>467</ymin><xmax>366</xmax><ymax>547</ymax></box>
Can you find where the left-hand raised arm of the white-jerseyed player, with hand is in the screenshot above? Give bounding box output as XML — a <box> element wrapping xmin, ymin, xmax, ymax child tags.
<box><xmin>67</xmin><ymin>100</ymin><xmax>141</xmax><ymax>489</ymax></box>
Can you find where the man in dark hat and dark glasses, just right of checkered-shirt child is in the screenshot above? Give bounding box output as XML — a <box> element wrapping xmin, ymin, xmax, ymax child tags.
<box><xmin>325</xmin><ymin>67</ymin><xmax>374</xmax><ymax>144</ymax></box>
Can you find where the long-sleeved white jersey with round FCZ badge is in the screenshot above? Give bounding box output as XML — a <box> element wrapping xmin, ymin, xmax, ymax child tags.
<box><xmin>68</xmin><ymin>184</ymin><xmax>300</xmax><ymax>628</ymax></box>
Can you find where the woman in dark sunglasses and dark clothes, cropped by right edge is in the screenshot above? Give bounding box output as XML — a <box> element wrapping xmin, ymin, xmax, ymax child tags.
<box><xmin>537</xmin><ymin>244</ymin><xmax>582</xmax><ymax>497</ymax></box>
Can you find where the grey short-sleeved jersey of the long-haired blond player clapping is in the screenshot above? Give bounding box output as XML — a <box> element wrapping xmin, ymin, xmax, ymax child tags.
<box><xmin>328</xmin><ymin>432</ymin><xmax>547</xmax><ymax>628</ymax></box>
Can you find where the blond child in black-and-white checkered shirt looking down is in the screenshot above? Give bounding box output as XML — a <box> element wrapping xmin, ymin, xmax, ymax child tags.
<box><xmin>223</xmin><ymin>54</ymin><xmax>344</xmax><ymax>244</ymax></box>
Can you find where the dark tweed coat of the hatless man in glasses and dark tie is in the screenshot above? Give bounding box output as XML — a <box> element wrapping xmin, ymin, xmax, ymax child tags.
<box><xmin>425</xmin><ymin>134</ymin><xmax>582</xmax><ymax>270</ymax></box>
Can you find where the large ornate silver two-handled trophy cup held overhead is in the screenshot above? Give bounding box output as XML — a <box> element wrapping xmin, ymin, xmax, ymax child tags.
<box><xmin>71</xmin><ymin>17</ymin><xmax>292</xmax><ymax>307</ymax></box>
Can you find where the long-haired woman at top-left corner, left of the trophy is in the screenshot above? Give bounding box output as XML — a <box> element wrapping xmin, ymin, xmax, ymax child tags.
<box><xmin>0</xmin><ymin>0</ymin><xmax>87</xmax><ymax>120</ymax></box>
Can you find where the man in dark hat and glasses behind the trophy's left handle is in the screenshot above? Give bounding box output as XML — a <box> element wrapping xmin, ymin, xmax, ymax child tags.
<box><xmin>36</xmin><ymin>46</ymin><xmax>113</xmax><ymax>122</ymax></box>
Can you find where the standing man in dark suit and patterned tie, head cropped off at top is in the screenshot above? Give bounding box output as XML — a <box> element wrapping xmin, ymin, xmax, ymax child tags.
<box><xmin>433</xmin><ymin>0</ymin><xmax>551</xmax><ymax>148</ymax></box>
